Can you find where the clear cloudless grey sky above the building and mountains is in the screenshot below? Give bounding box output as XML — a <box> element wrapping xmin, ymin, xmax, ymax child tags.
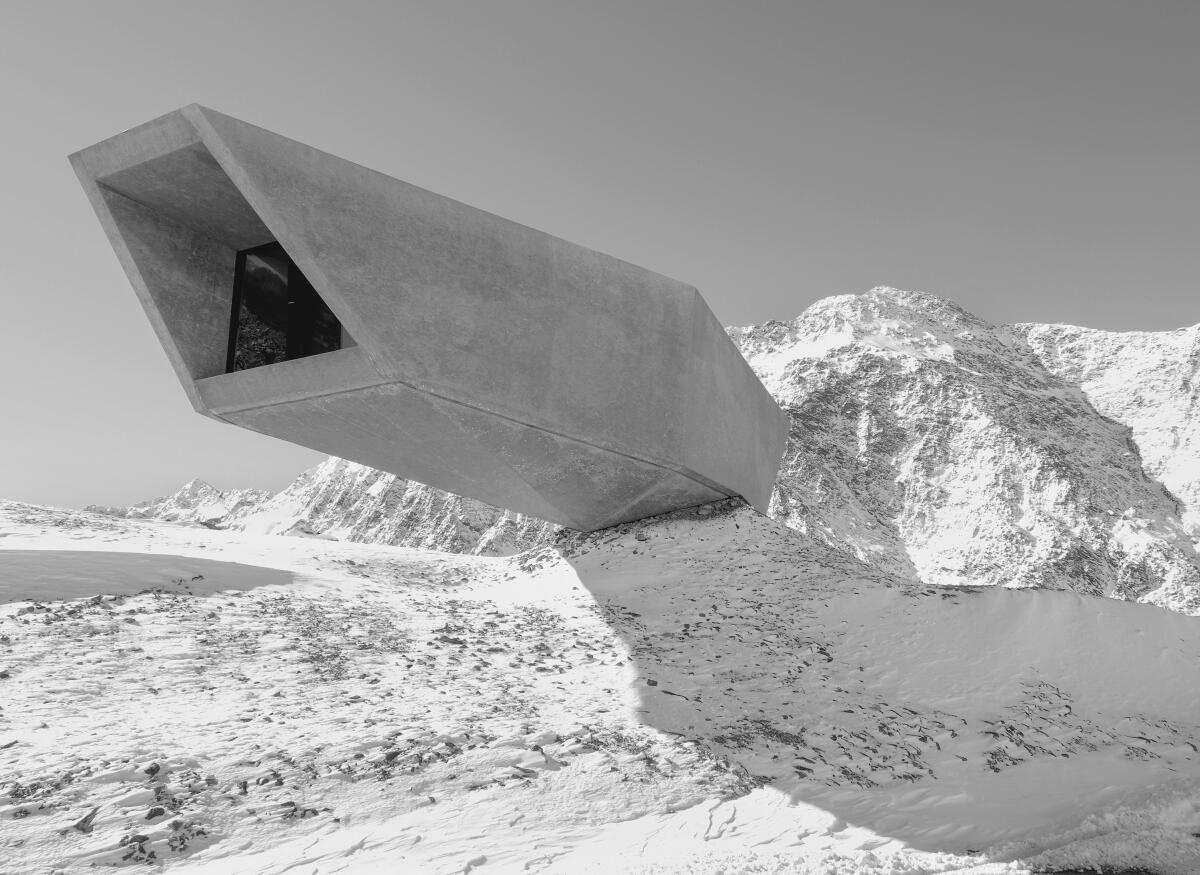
<box><xmin>0</xmin><ymin>0</ymin><xmax>1200</xmax><ymax>507</ymax></box>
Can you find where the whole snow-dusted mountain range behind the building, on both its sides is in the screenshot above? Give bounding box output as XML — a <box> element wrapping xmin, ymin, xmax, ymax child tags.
<box><xmin>90</xmin><ymin>288</ymin><xmax>1200</xmax><ymax>613</ymax></box>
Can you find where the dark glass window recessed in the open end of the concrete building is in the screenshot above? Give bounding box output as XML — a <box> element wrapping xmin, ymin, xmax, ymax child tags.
<box><xmin>226</xmin><ymin>242</ymin><xmax>342</xmax><ymax>371</ymax></box>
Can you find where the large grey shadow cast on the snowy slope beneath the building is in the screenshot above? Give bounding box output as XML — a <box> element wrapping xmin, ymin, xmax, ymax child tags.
<box><xmin>542</xmin><ymin>502</ymin><xmax>1200</xmax><ymax>857</ymax></box>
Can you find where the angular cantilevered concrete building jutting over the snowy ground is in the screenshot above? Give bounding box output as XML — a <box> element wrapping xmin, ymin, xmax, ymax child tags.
<box><xmin>71</xmin><ymin>104</ymin><xmax>787</xmax><ymax>531</ymax></box>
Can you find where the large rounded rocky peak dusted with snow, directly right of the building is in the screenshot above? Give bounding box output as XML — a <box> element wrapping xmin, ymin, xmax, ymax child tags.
<box><xmin>731</xmin><ymin>288</ymin><xmax>1200</xmax><ymax>611</ymax></box>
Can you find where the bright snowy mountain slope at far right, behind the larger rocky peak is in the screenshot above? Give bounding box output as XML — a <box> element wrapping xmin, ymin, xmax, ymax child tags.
<box><xmin>1014</xmin><ymin>324</ymin><xmax>1200</xmax><ymax>534</ymax></box>
